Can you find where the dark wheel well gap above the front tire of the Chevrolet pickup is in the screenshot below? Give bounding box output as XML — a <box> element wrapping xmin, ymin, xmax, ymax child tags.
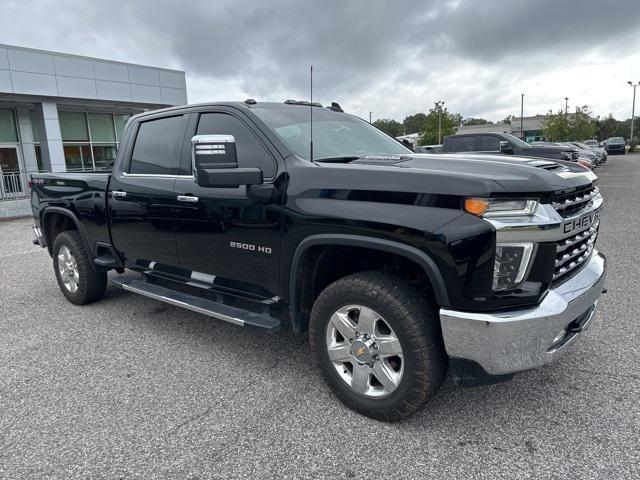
<box><xmin>293</xmin><ymin>245</ymin><xmax>435</xmax><ymax>331</ymax></box>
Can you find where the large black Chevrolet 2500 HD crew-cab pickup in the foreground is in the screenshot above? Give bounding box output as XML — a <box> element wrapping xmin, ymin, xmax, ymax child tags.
<box><xmin>31</xmin><ymin>100</ymin><xmax>605</xmax><ymax>420</ymax></box>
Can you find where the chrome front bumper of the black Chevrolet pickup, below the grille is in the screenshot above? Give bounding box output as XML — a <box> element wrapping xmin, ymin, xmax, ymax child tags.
<box><xmin>440</xmin><ymin>251</ymin><xmax>606</xmax><ymax>375</ymax></box>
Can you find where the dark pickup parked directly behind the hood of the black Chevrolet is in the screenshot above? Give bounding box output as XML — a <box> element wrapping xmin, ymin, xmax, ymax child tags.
<box><xmin>442</xmin><ymin>132</ymin><xmax>578</xmax><ymax>162</ymax></box>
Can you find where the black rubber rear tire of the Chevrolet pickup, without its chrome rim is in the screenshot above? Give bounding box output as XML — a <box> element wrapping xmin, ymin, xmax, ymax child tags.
<box><xmin>53</xmin><ymin>230</ymin><xmax>107</xmax><ymax>305</ymax></box>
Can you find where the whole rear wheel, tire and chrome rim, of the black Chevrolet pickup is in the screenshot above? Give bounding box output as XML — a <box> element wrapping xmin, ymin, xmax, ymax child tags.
<box><xmin>53</xmin><ymin>230</ymin><xmax>107</xmax><ymax>305</ymax></box>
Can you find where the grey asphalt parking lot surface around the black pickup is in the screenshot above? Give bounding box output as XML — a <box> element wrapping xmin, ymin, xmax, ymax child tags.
<box><xmin>0</xmin><ymin>154</ymin><xmax>640</xmax><ymax>479</ymax></box>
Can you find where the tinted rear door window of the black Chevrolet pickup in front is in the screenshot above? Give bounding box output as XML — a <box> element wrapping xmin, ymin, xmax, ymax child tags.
<box><xmin>129</xmin><ymin>115</ymin><xmax>186</xmax><ymax>175</ymax></box>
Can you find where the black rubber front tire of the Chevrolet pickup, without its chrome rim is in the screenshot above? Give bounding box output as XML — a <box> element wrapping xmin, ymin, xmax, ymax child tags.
<box><xmin>309</xmin><ymin>272</ymin><xmax>448</xmax><ymax>421</ymax></box>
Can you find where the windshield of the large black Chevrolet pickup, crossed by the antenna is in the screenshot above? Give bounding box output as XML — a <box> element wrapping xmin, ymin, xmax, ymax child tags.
<box><xmin>251</xmin><ymin>106</ymin><xmax>413</xmax><ymax>160</ymax></box>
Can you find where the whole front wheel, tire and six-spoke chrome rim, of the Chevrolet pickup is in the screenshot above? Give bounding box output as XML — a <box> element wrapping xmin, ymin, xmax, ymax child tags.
<box><xmin>309</xmin><ymin>272</ymin><xmax>447</xmax><ymax>421</ymax></box>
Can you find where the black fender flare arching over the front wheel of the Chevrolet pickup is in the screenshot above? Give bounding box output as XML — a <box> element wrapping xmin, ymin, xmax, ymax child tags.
<box><xmin>289</xmin><ymin>234</ymin><xmax>449</xmax><ymax>317</ymax></box>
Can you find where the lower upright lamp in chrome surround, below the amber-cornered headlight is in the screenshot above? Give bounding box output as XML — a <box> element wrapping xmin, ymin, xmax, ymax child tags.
<box><xmin>493</xmin><ymin>243</ymin><xmax>533</xmax><ymax>291</ymax></box>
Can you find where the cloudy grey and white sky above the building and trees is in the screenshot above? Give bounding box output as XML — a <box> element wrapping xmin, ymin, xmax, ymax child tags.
<box><xmin>0</xmin><ymin>0</ymin><xmax>640</xmax><ymax>124</ymax></box>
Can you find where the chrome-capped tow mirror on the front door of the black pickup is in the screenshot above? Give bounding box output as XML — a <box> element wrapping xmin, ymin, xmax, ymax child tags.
<box><xmin>191</xmin><ymin>135</ymin><xmax>262</xmax><ymax>188</ymax></box>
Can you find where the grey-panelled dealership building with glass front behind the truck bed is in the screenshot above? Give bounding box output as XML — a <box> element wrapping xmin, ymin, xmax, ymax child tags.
<box><xmin>0</xmin><ymin>44</ymin><xmax>187</xmax><ymax>212</ymax></box>
